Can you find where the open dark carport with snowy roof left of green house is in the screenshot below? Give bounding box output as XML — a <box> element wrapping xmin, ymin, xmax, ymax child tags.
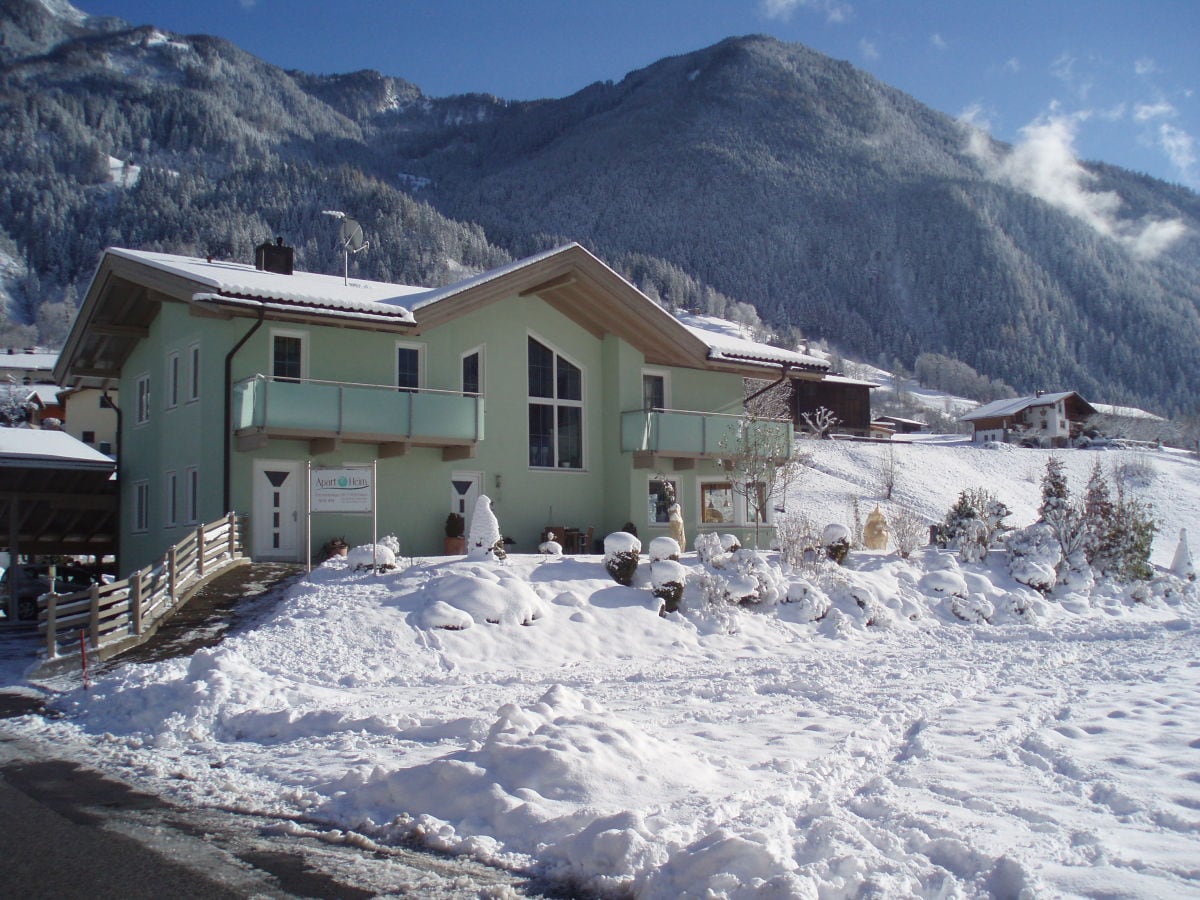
<box><xmin>0</xmin><ymin>428</ymin><xmax>118</xmax><ymax>623</ymax></box>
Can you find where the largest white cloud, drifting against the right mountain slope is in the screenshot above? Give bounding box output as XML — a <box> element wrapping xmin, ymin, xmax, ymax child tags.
<box><xmin>962</xmin><ymin>113</ymin><xmax>1187</xmax><ymax>259</ymax></box>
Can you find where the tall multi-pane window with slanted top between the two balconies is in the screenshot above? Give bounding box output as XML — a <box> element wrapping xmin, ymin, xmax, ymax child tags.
<box><xmin>529</xmin><ymin>337</ymin><xmax>583</xmax><ymax>469</ymax></box>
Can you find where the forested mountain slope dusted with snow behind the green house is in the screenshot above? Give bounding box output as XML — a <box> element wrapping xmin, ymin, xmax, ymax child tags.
<box><xmin>0</xmin><ymin>0</ymin><xmax>1200</xmax><ymax>413</ymax></box>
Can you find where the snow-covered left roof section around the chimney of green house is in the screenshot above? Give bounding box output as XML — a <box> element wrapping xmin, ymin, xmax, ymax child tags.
<box><xmin>108</xmin><ymin>247</ymin><xmax>424</xmax><ymax>323</ymax></box>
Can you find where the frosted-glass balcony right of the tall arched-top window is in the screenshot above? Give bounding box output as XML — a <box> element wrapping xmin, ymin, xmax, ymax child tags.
<box><xmin>620</xmin><ymin>409</ymin><xmax>793</xmax><ymax>469</ymax></box>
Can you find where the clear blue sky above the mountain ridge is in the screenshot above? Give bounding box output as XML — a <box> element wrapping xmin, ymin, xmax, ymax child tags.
<box><xmin>77</xmin><ymin>0</ymin><xmax>1200</xmax><ymax>190</ymax></box>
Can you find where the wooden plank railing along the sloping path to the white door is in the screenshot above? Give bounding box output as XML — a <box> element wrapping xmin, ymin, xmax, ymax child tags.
<box><xmin>37</xmin><ymin>512</ymin><xmax>246</xmax><ymax>661</ymax></box>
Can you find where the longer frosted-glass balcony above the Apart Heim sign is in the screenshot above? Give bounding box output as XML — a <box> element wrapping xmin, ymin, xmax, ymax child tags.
<box><xmin>233</xmin><ymin>374</ymin><xmax>484</xmax><ymax>460</ymax></box>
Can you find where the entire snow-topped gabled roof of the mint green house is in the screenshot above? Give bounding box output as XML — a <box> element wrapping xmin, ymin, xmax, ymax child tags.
<box><xmin>55</xmin><ymin>244</ymin><xmax>828</xmax><ymax>386</ymax></box>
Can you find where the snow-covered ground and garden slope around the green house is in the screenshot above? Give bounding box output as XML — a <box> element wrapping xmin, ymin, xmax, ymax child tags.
<box><xmin>4</xmin><ymin>442</ymin><xmax>1200</xmax><ymax>898</ymax></box>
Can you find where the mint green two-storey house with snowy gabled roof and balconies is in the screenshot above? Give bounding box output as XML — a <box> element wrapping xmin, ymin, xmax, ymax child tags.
<box><xmin>55</xmin><ymin>244</ymin><xmax>824</xmax><ymax>569</ymax></box>
